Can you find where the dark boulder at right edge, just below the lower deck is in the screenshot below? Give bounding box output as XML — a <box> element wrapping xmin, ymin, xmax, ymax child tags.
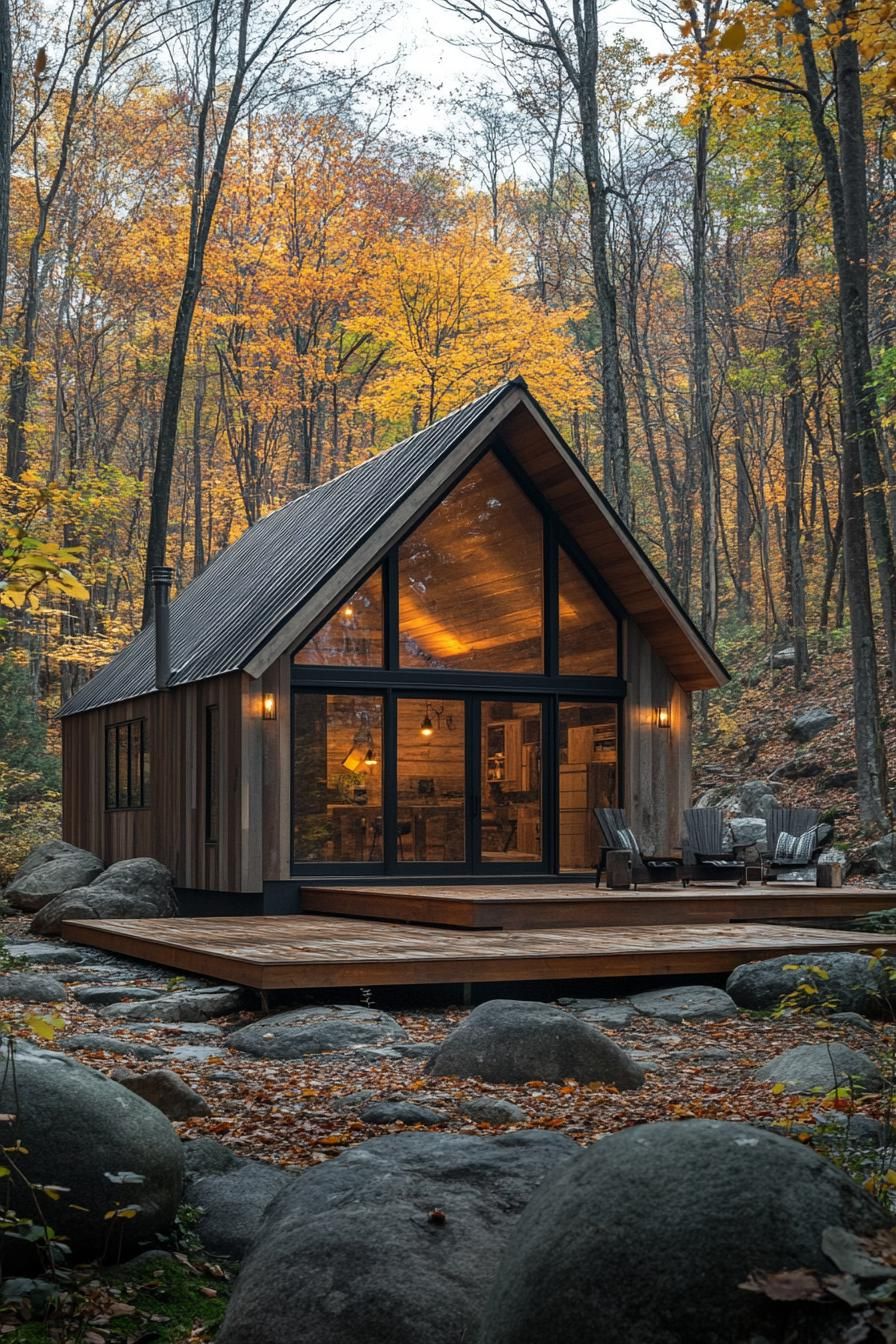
<box><xmin>725</xmin><ymin>952</ymin><xmax>892</xmax><ymax>1017</ymax></box>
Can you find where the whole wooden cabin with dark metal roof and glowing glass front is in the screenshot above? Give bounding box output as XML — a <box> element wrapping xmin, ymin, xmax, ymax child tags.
<box><xmin>62</xmin><ymin>380</ymin><xmax>727</xmax><ymax>914</ymax></box>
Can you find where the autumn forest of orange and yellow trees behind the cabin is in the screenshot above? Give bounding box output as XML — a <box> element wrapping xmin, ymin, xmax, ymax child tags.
<box><xmin>0</xmin><ymin>0</ymin><xmax>896</xmax><ymax>860</ymax></box>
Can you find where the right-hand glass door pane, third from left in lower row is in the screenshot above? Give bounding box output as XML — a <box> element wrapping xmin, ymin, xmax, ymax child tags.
<box><xmin>478</xmin><ymin>699</ymin><xmax>544</xmax><ymax>866</ymax></box>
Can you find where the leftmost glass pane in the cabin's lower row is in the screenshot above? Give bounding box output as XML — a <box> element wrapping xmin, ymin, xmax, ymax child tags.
<box><xmin>293</xmin><ymin>691</ymin><xmax>383</xmax><ymax>864</ymax></box>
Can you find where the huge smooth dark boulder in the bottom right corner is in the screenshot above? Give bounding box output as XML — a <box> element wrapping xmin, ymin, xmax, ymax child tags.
<box><xmin>478</xmin><ymin>1120</ymin><xmax>892</xmax><ymax>1344</ymax></box>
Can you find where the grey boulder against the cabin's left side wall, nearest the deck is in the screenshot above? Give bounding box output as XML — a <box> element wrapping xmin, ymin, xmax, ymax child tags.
<box><xmin>26</xmin><ymin>859</ymin><xmax>177</xmax><ymax>935</ymax></box>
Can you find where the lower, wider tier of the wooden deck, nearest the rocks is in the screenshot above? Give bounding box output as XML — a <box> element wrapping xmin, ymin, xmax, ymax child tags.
<box><xmin>63</xmin><ymin>915</ymin><xmax>896</xmax><ymax>989</ymax></box>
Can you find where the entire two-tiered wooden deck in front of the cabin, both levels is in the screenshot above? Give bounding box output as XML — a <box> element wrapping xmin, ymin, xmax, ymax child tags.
<box><xmin>63</xmin><ymin>886</ymin><xmax>896</xmax><ymax>989</ymax></box>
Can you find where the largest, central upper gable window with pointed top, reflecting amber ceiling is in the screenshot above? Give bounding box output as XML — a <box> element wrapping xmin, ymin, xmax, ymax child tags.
<box><xmin>398</xmin><ymin>453</ymin><xmax>544</xmax><ymax>673</ymax></box>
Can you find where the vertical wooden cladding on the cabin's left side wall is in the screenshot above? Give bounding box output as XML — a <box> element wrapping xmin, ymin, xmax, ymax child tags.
<box><xmin>62</xmin><ymin>672</ymin><xmax>252</xmax><ymax>891</ymax></box>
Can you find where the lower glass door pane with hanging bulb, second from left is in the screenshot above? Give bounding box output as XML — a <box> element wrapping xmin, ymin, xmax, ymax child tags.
<box><xmin>395</xmin><ymin>696</ymin><xmax>467</xmax><ymax>866</ymax></box>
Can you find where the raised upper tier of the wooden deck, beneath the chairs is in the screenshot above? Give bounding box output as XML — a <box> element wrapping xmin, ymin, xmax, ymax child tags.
<box><xmin>301</xmin><ymin>883</ymin><xmax>895</xmax><ymax>929</ymax></box>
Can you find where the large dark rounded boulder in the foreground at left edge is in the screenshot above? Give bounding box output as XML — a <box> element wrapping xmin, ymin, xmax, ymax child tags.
<box><xmin>0</xmin><ymin>1043</ymin><xmax>184</xmax><ymax>1261</ymax></box>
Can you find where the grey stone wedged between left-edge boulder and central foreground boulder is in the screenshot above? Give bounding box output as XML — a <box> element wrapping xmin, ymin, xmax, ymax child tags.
<box><xmin>189</xmin><ymin>1161</ymin><xmax>297</xmax><ymax>1259</ymax></box>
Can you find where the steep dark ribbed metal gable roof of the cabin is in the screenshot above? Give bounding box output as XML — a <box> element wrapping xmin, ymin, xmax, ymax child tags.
<box><xmin>60</xmin><ymin>379</ymin><xmax>727</xmax><ymax>716</ymax></box>
